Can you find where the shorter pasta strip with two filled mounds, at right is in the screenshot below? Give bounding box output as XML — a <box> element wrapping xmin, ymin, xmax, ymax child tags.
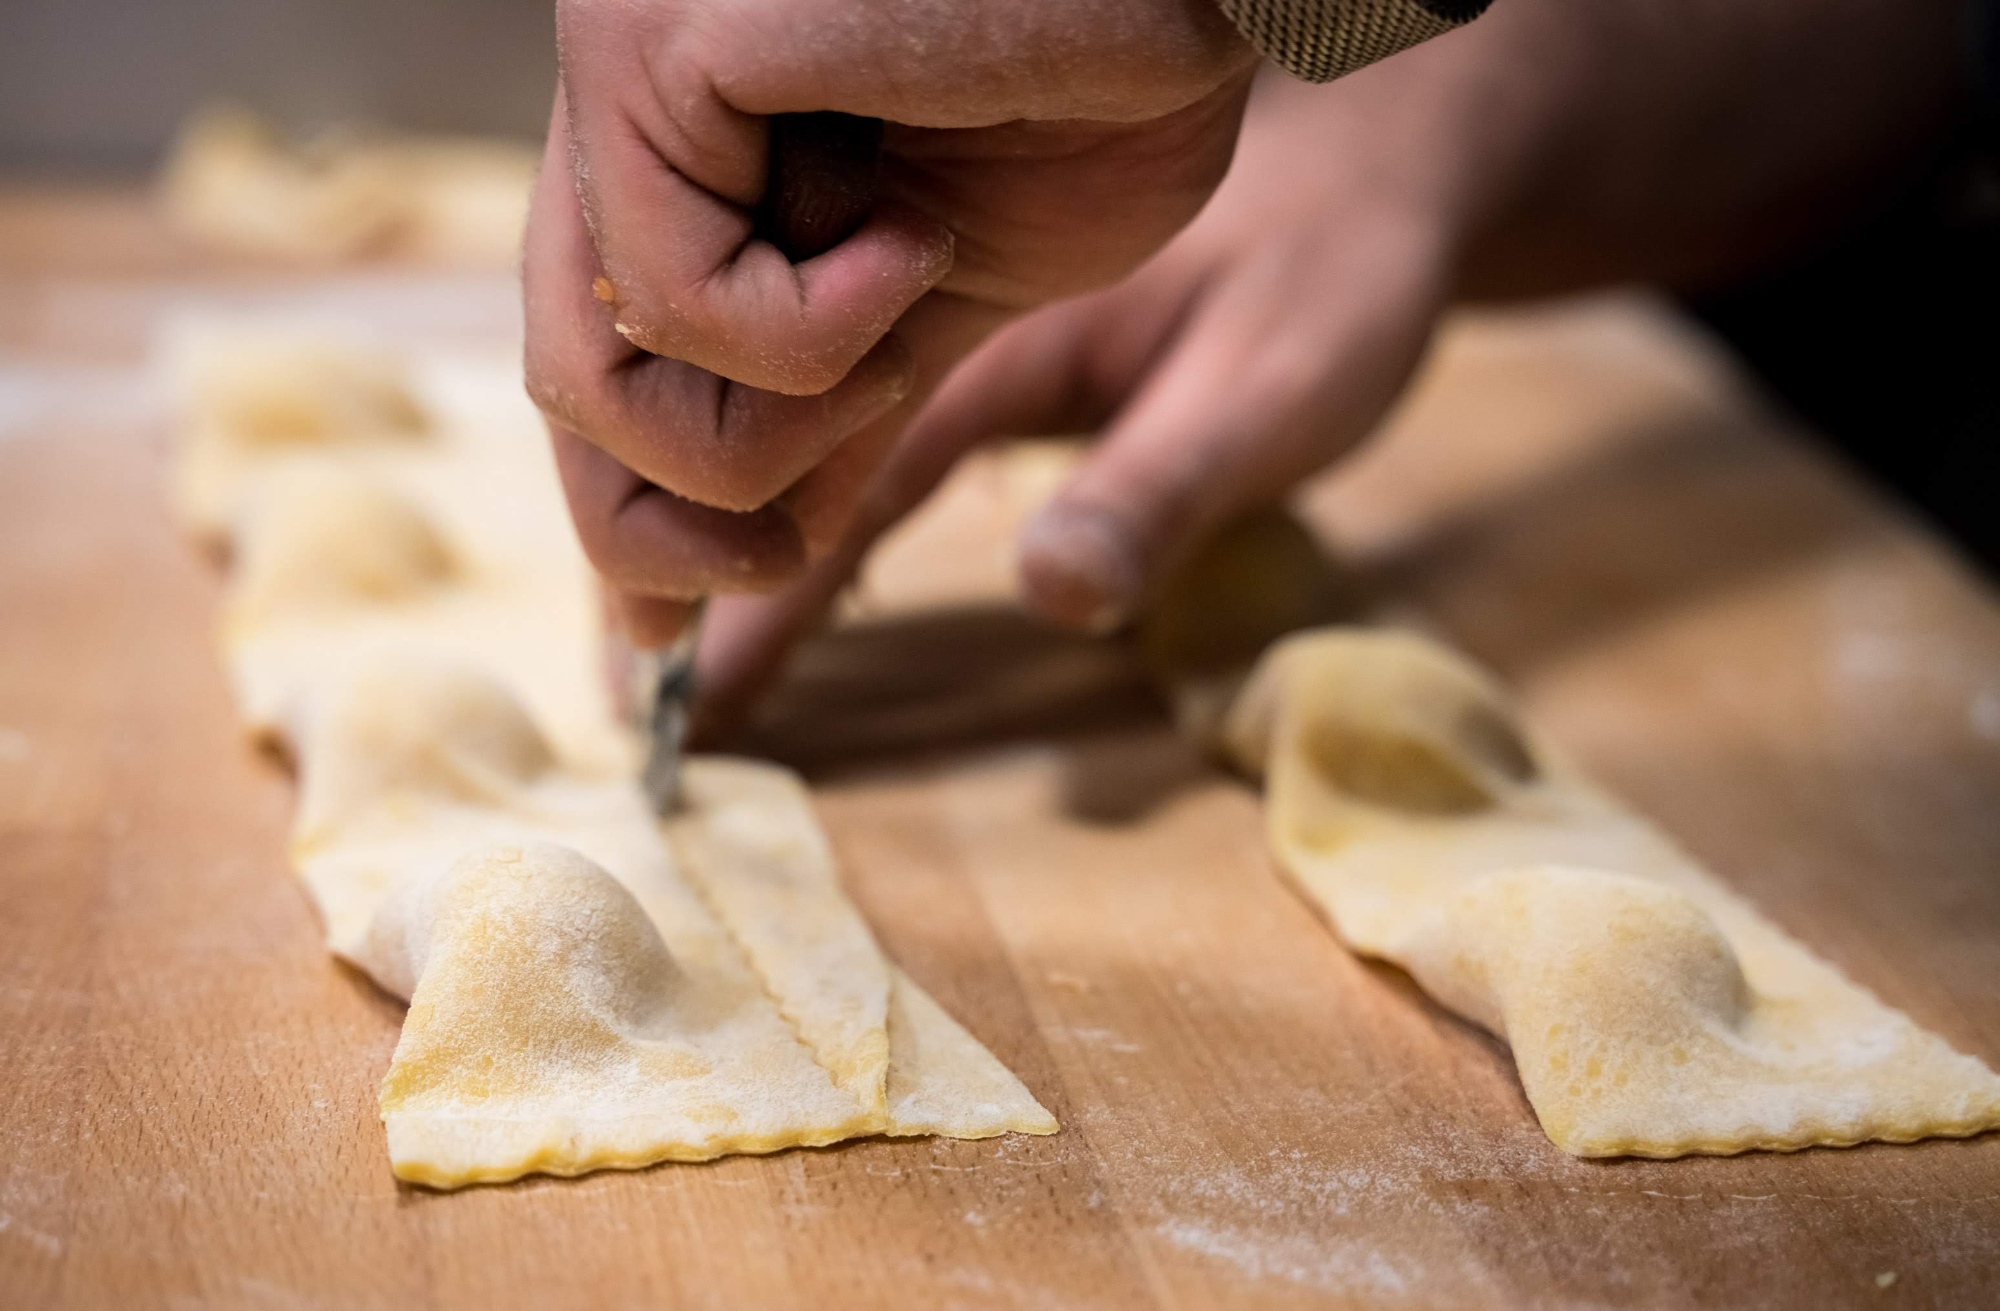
<box><xmin>1226</xmin><ymin>630</ymin><xmax>2000</xmax><ymax>1157</ymax></box>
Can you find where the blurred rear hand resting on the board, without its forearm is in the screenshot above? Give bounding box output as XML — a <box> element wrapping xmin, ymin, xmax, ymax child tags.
<box><xmin>698</xmin><ymin>63</ymin><xmax>1458</xmax><ymax>737</ymax></box>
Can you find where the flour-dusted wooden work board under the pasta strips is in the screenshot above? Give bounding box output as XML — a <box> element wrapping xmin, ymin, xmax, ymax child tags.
<box><xmin>0</xmin><ymin>189</ymin><xmax>2000</xmax><ymax>1307</ymax></box>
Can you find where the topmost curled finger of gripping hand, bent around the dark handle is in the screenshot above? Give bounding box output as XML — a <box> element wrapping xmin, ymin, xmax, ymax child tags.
<box><xmin>550</xmin><ymin>2</ymin><xmax>952</xmax><ymax>396</ymax></box>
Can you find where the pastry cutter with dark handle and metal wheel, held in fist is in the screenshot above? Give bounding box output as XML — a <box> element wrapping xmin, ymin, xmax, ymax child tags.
<box><xmin>632</xmin><ymin>112</ymin><xmax>882</xmax><ymax>815</ymax></box>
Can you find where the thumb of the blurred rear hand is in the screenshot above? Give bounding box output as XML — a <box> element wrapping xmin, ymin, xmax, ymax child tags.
<box><xmin>1020</xmin><ymin>254</ymin><xmax>1442</xmax><ymax>632</ymax></box>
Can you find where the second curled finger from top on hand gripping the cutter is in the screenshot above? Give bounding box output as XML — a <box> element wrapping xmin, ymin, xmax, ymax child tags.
<box><xmin>524</xmin><ymin>96</ymin><xmax>914</xmax><ymax>510</ymax></box>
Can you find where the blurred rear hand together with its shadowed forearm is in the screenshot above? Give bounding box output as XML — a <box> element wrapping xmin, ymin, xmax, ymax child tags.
<box><xmin>696</xmin><ymin>0</ymin><xmax>1954</xmax><ymax>737</ymax></box>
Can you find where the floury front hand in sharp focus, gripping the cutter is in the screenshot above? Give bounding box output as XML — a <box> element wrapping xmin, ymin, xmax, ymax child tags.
<box><xmin>524</xmin><ymin>0</ymin><xmax>1254</xmax><ymax>642</ymax></box>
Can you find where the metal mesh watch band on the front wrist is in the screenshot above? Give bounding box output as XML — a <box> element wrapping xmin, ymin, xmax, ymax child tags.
<box><xmin>1218</xmin><ymin>0</ymin><xmax>1490</xmax><ymax>82</ymax></box>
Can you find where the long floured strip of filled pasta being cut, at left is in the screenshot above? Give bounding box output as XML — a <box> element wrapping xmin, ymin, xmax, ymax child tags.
<box><xmin>178</xmin><ymin>319</ymin><xmax>1056</xmax><ymax>1187</ymax></box>
